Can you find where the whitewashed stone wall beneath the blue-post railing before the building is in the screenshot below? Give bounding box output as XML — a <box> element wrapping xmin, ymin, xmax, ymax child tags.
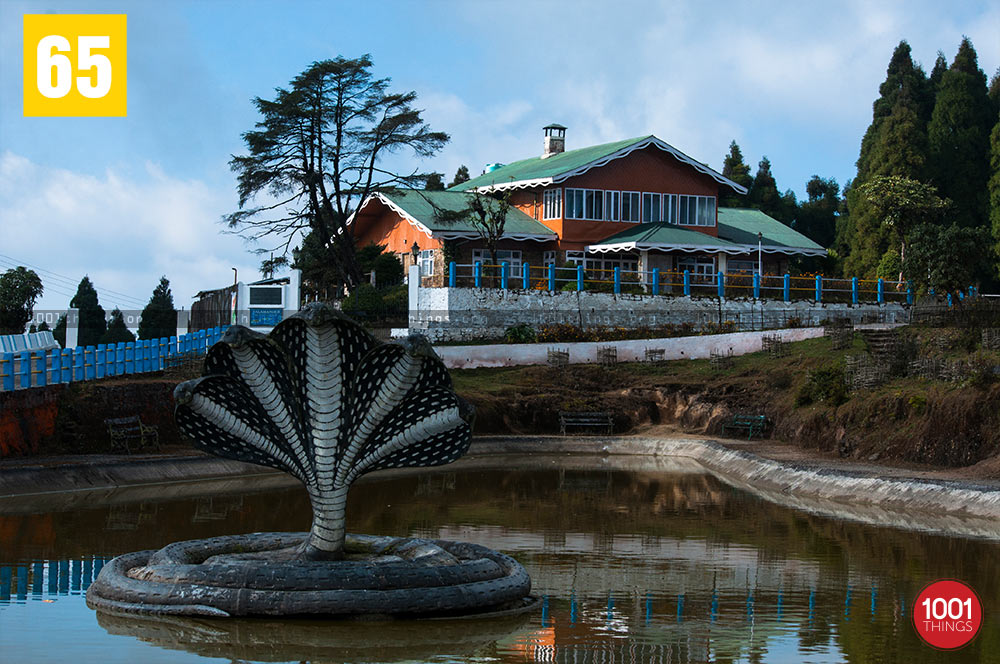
<box><xmin>402</xmin><ymin>280</ymin><xmax>909</xmax><ymax>341</ymax></box>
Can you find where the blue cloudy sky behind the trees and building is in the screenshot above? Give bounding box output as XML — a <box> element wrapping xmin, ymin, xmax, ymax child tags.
<box><xmin>0</xmin><ymin>0</ymin><xmax>1000</xmax><ymax>311</ymax></box>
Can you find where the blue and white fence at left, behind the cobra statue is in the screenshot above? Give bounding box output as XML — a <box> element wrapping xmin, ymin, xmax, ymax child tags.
<box><xmin>0</xmin><ymin>327</ymin><xmax>227</xmax><ymax>392</ymax></box>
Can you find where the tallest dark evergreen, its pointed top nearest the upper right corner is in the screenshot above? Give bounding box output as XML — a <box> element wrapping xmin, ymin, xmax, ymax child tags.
<box><xmin>927</xmin><ymin>38</ymin><xmax>996</xmax><ymax>228</ymax></box>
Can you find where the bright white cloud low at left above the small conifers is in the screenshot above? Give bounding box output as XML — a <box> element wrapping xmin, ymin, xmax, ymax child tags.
<box><xmin>0</xmin><ymin>151</ymin><xmax>258</xmax><ymax>310</ymax></box>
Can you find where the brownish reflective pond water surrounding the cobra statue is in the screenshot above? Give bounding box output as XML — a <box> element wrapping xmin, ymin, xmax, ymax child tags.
<box><xmin>0</xmin><ymin>456</ymin><xmax>1000</xmax><ymax>664</ymax></box>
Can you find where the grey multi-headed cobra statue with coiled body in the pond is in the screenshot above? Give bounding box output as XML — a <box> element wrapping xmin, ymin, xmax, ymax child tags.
<box><xmin>87</xmin><ymin>304</ymin><xmax>534</xmax><ymax>616</ymax></box>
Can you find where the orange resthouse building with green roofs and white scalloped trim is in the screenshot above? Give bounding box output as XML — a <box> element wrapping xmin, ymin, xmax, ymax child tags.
<box><xmin>349</xmin><ymin>124</ymin><xmax>826</xmax><ymax>285</ymax></box>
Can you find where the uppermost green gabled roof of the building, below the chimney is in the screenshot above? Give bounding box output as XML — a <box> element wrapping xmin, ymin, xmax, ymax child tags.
<box><xmin>449</xmin><ymin>134</ymin><xmax>746</xmax><ymax>194</ymax></box>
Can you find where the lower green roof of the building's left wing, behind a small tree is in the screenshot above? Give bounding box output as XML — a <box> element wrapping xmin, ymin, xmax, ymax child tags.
<box><xmin>381</xmin><ymin>189</ymin><xmax>556</xmax><ymax>239</ymax></box>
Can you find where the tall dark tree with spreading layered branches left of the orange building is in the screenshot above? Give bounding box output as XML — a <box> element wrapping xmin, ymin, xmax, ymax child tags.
<box><xmin>225</xmin><ymin>55</ymin><xmax>448</xmax><ymax>289</ymax></box>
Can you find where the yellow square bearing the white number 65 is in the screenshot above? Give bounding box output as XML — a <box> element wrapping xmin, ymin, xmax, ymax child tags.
<box><xmin>24</xmin><ymin>14</ymin><xmax>128</xmax><ymax>117</ymax></box>
